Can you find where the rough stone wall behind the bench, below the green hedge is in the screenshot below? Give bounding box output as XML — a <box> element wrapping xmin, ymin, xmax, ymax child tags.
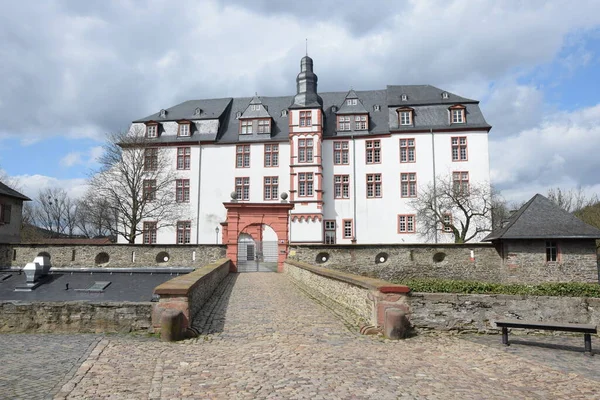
<box><xmin>410</xmin><ymin>293</ymin><xmax>600</xmax><ymax>333</ymax></box>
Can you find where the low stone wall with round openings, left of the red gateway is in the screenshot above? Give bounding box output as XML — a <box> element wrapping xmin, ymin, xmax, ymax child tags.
<box><xmin>0</xmin><ymin>244</ymin><xmax>226</xmax><ymax>268</ymax></box>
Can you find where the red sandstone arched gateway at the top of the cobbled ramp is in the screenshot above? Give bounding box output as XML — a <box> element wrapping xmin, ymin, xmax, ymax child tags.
<box><xmin>221</xmin><ymin>202</ymin><xmax>294</xmax><ymax>272</ymax></box>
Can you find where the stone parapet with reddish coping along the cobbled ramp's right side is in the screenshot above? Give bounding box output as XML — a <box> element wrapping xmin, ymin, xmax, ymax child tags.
<box><xmin>284</xmin><ymin>260</ymin><xmax>410</xmax><ymax>327</ymax></box>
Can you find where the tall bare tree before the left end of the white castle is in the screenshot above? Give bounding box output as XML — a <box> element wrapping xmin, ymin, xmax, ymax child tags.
<box><xmin>90</xmin><ymin>130</ymin><xmax>184</xmax><ymax>243</ymax></box>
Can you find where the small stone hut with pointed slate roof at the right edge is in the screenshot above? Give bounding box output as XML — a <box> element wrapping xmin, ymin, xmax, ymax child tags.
<box><xmin>483</xmin><ymin>194</ymin><xmax>600</xmax><ymax>282</ymax></box>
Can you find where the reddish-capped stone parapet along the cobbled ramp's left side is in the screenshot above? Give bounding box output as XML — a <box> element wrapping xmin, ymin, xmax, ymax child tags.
<box><xmin>152</xmin><ymin>258</ymin><xmax>231</xmax><ymax>332</ymax></box>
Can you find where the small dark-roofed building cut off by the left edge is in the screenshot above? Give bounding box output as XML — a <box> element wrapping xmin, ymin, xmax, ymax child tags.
<box><xmin>0</xmin><ymin>182</ymin><xmax>31</xmax><ymax>243</ymax></box>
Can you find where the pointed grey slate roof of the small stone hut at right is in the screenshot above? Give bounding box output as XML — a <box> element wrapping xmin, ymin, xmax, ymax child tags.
<box><xmin>483</xmin><ymin>194</ymin><xmax>600</xmax><ymax>242</ymax></box>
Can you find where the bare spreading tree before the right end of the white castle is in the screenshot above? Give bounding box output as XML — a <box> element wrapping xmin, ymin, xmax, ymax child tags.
<box><xmin>410</xmin><ymin>175</ymin><xmax>497</xmax><ymax>243</ymax></box>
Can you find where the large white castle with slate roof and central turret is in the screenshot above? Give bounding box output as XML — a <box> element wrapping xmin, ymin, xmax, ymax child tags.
<box><xmin>123</xmin><ymin>56</ymin><xmax>491</xmax><ymax>244</ymax></box>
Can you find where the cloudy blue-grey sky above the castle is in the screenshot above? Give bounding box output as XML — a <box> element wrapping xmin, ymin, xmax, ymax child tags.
<box><xmin>0</xmin><ymin>0</ymin><xmax>600</xmax><ymax>200</ymax></box>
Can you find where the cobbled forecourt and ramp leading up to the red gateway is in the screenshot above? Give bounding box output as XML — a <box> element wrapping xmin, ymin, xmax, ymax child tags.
<box><xmin>0</xmin><ymin>273</ymin><xmax>600</xmax><ymax>399</ymax></box>
